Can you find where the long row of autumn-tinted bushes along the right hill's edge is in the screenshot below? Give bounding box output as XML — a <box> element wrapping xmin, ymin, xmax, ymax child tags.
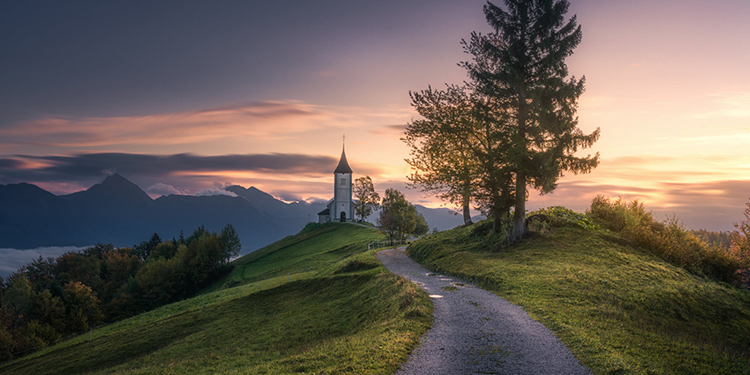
<box><xmin>587</xmin><ymin>195</ymin><xmax>741</xmax><ymax>283</ymax></box>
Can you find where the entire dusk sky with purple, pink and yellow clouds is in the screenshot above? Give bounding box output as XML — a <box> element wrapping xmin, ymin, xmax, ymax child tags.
<box><xmin>0</xmin><ymin>0</ymin><xmax>750</xmax><ymax>230</ymax></box>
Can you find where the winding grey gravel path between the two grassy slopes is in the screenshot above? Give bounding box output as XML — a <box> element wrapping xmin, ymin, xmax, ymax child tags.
<box><xmin>377</xmin><ymin>248</ymin><xmax>591</xmax><ymax>375</ymax></box>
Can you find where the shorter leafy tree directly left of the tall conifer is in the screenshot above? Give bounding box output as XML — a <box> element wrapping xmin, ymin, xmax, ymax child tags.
<box><xmin>402</xmin><ymin>83</ymin><xmax>513</xmax><ymax>231</ymax></box>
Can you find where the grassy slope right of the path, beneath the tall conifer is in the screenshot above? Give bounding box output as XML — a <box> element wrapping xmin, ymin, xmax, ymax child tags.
<box><xmin>408</xmin><ymin>227</ymin><xmax>750</xmax><ymax>374</ymax></box>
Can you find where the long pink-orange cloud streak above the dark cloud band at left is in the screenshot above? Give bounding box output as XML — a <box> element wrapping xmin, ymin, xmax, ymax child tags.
<box><xmin>0</xmin><ymin>101</ymin><xmax>347</xmax><ymax>149</ymax></box>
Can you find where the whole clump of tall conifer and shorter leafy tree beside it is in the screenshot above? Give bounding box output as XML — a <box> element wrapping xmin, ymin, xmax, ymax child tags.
<box><xmin>403</xmin><ymin>0</ymin><xmax>599</xmax><ymax>239</ymax></box>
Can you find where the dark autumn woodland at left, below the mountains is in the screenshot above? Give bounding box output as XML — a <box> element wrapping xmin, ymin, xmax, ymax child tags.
<box><xmin>0</xmin><ymin>224</ymin><xmax>241</xmax><ymax>361</ymax></box>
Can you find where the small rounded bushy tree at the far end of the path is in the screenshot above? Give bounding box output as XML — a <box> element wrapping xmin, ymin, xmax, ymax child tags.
<box><xmin>378</xmin><ymin>189</ymin><xmax>429</xmax><ymax>241</ymax></box>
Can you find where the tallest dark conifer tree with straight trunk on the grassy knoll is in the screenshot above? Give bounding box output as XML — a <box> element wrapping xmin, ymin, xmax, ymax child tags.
<box><xmin>461</xmin><ymin>0</ymin><xmax>599</xmax><ymax>240</ymax></box>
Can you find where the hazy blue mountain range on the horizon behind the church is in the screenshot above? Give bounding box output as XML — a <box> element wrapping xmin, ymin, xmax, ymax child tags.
<box><xmin>0</xmin><ymin>174</ymin><xmax>461</xmax><ymax>254</ymax></box>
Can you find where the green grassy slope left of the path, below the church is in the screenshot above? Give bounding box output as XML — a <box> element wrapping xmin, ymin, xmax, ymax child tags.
<box><xmin>0</xmin><ymin>224</ymin><xmax>431</xmax><ymax>375</ymax></box>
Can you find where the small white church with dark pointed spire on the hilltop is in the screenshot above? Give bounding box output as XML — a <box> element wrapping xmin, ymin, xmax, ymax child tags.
<box><xmin>318</xmin><ymin>147</ymin><xmax>354</xmax><ymax>223</ymax></box>
